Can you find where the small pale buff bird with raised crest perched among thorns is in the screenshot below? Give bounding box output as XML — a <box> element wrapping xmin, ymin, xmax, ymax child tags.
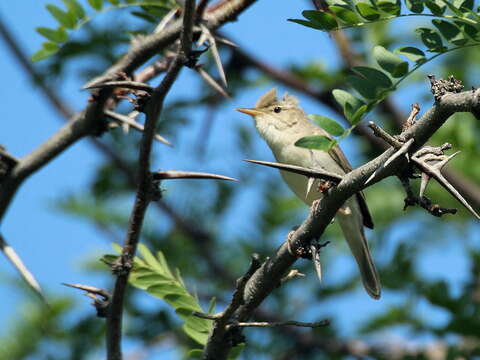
<box><xmin>236</xmin><ymin>88</ymin><xmax>381</xmax><ymax>299</ymax></box>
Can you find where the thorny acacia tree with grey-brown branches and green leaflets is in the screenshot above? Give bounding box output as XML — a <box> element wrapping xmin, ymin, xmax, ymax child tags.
<box><xmin>0</xmin><ymin>0</ymin><xmax>480</xmax><ymax>359</ymax></box>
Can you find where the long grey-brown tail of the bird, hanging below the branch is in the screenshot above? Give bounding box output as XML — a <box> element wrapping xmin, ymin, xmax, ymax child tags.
<box><xmin>336</xmin><ymin>198</ymin><xmax>381</xmax><ymax>299</ymax></box>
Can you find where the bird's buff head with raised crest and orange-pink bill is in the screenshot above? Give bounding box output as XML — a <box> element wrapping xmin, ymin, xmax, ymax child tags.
<box><xmin>236</xmin><ymin>88</ymin><xmax>306</xmax><ymax>140</ymax></box>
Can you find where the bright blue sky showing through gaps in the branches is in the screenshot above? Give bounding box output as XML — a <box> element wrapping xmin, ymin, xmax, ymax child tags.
<box><xmin>0</xmin><ymin>0</ymin><xmax>476</xmax><ymax>358</ymax></box>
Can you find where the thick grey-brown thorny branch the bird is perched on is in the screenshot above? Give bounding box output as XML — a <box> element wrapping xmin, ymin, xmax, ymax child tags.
<box><xmin>204</xmin><ymin>90</ymin><xmax>480</xmax><ymax>359</ymax></box>
